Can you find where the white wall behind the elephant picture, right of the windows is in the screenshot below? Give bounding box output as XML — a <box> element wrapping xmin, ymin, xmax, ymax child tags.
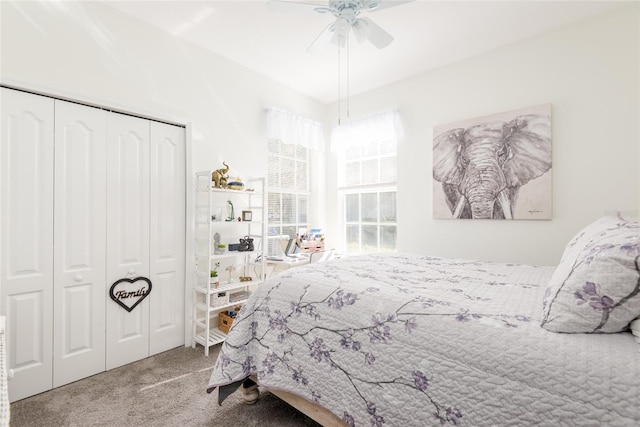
<box><xmin>329</xmin><ymin>3</ymin><xmax>640</xmax><ymax>265</ymax></box>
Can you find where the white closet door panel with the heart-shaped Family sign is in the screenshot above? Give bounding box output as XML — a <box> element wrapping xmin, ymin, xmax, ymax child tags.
<box><xmin>106</xmin><ymin>113</ymin><xmax>149</xmax><ymax>369</ymax></box>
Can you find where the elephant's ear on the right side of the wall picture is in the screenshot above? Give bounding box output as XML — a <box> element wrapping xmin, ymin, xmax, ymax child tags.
<box><xmin>503</xmin><ymin>114</ymin><xmax>551</xmax><ymax>188</ymax></box>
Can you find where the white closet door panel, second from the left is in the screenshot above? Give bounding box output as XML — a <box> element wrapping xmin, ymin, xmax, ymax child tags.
<box><xmin>53</xmin><ymin>100</ymin><xmax>107</xmax><ymax>387</ymax></box>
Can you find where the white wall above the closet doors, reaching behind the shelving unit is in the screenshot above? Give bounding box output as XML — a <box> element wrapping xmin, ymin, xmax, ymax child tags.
<box><xmin>0</xmin><ymin>1</ymin><xmax>326</xmax><ymax>187</ymax></box>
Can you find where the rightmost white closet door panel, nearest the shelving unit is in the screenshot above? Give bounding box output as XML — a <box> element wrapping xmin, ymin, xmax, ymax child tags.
<box><xmin>149</xmin><ymin>122</ymin><xmax>185</xmax><ymax>355</ymax></box>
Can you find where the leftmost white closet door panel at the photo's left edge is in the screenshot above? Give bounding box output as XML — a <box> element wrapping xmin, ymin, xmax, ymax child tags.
<box><xmin>0</xmin><ymin>88</ymin><xmax>53</xmax><ymax>401</ymax></box>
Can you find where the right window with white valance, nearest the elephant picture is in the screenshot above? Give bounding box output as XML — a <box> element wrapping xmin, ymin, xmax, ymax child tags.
<box><xmin>332</xmin><ymin>112</ymin><xmax>400</xmax><ymax>253</ymax></box>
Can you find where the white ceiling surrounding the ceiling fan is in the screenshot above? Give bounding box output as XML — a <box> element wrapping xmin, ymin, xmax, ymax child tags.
<box><xmin>105</xmin><ymin>0</ymin><xmax>624</xmax><ymax>103</ymax></box>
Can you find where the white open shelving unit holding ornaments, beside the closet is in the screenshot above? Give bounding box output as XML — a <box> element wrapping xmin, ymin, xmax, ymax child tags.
<box><xmin>191</xmin><ymin>170</ymin><xmax>266</xmax><ymax>356</ymax></box>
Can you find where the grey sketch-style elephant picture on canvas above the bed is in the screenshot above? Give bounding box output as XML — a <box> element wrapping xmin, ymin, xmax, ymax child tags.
<box><xmin>433</xmin><ymin>105</ymin><xmax>551</xmax><ymax>219</ymax></box>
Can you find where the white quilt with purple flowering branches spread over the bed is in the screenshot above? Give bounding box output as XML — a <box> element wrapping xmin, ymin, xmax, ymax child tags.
<box><xmin>209</xmin><ymin>254</ymin><xmax>640</xmax><ymax>426</ymax></box>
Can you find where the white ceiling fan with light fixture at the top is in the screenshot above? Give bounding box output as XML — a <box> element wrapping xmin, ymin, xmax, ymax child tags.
<box><xmin>267</xmin><ymin>0</ymin><xmax>407</xmax><ymax>53</ymax></box>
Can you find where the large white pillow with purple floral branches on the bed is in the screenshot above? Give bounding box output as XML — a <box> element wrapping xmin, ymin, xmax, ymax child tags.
<box><xmin>541</xmin><ymin>216</ymin><xmax>640</xmax><ymax>333</ymax></box>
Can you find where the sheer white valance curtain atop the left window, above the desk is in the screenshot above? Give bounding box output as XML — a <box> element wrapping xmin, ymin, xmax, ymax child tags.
<box><xmin>267</xmin><ymin>107</ymin><xmax>324</xmax><ymax>151</ymax></box>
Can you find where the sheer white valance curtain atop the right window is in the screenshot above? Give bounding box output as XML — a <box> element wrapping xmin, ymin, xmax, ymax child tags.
<box><xmin>331</xmin><ymin>110</ymin><xmax>404</xmax><ymax>151</ymax></box>
